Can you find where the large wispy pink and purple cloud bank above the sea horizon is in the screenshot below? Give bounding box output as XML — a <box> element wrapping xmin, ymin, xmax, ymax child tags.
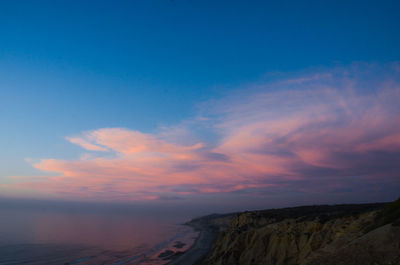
<box><xmin>8</xmin><ymin>64</ymin><xmax>400</xmax><ymax>200</ymax></box>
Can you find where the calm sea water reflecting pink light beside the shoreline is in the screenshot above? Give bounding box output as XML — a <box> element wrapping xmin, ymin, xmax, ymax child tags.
<box><xmin>0</xmin><ymin>202</ymin><xmax>197</xmax><ymax>265</ymax></box>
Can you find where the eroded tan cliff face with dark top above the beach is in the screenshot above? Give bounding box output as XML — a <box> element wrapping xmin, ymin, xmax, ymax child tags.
<box><xmin>201</xmin><ymin>204</ymin><xmax>400</xmax><ymax>265</ymax></box>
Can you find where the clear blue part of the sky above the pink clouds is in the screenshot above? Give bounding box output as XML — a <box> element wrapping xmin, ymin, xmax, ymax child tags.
<box><xmin>0</xmin><ymin>0</ymin><xmax>400</xmax><ymax>204</ymax></box>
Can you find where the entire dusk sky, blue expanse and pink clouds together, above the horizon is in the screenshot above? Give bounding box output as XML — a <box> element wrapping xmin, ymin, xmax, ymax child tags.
<box><xmin>0</xmin><ymin>0</ymin><xmax>400</xmax><ymax>209</ymax></box>
